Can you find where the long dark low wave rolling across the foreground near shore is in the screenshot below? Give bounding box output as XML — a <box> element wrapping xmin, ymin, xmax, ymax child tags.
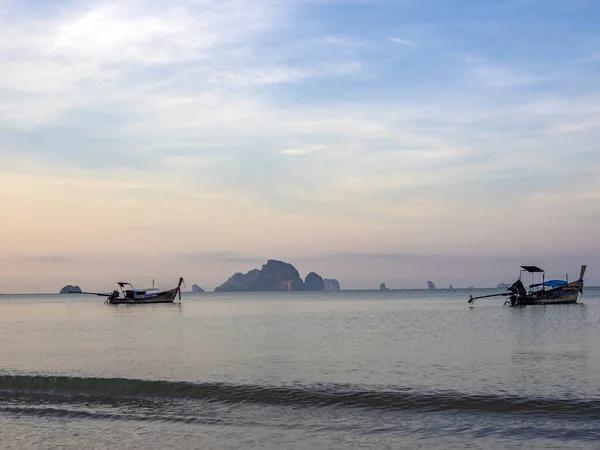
<box><xmin>0</xmin><ymin>375</ymin><xmax>600</xmax><ymax>419</ymax></box>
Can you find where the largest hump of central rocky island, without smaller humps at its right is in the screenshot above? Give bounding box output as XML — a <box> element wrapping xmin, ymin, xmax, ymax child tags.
<box><xmin>215</xmin><ymin>259</ymin><xmax>304</xmax><ymax>292</ymax></box>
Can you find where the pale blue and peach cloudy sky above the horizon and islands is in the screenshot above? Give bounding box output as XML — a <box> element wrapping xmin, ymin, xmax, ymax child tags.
<box><xmin>0</xmin><ymin>0</ymin><xmax>600</xmax><ymax>292</ymax></box>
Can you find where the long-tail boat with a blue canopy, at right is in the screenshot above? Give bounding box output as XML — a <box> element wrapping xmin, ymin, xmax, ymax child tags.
<box><xmin>469</xmin><ymin>265</ymin><xmax>587</xmax><ymax>306</ymax></box>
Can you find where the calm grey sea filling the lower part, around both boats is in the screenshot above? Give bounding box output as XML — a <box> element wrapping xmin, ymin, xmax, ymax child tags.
<box><xmin>0</xmin><ymin>287</ymin><xmax>600</xmax><ymax>450</ymax></box>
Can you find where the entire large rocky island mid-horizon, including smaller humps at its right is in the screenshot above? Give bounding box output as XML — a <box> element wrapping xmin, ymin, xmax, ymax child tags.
<box><xmin>215</xmin><ymin>259</ymin><xmax>340</xmax><ymax>292</ymax></box>
